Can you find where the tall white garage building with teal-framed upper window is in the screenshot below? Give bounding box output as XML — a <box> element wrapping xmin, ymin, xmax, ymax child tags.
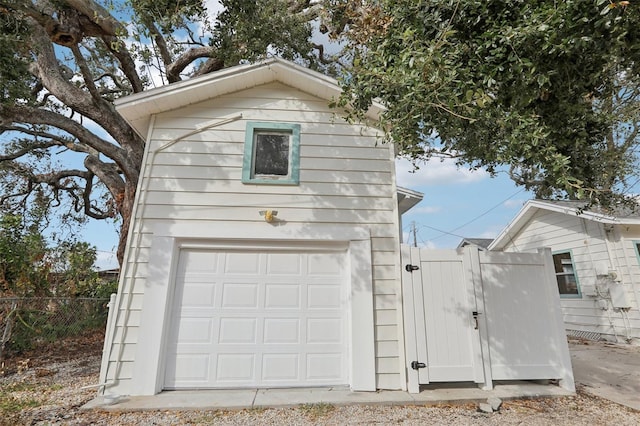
<box><xmin>100</xmin><ymin>59</ymin><xmax>422</xmax><ymax>395</ymax></box>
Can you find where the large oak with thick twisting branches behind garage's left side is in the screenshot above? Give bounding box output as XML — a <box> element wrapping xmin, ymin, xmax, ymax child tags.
<box><xmin>0</xmin><ymin>0</ymin><xmax>340</xmax><ymax>261</ymax></box>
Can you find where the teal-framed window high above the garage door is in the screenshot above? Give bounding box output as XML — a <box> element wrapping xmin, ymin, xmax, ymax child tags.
<box><xmin>242</xmin><ymin>122</ymin><xmax>300</xmax><ymax>185</ymax></box>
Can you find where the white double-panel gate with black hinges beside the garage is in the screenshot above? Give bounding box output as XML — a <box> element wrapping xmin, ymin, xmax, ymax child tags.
<box><xmin>402</xmin><ymin>246</ymin><xmax>574</xmax><ymax>392</ymax></box>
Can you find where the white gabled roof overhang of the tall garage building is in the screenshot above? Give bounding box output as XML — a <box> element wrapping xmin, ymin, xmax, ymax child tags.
<box><xmin>114</xmin><ymin>58</ymin><xmax>384</xmax><ymax>140</ymax></box>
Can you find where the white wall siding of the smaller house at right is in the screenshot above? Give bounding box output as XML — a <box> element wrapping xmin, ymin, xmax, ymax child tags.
<box><xmin>504</xmin><ymin>210</ymin><xmax>640</xmax><ymax>341</ymax></box>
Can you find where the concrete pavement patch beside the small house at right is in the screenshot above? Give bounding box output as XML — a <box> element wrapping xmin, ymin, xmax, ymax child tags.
<box><xmin>569</xmin><ymin>339</ymin><xmax>640</xmax><ymax>410</ymax></box>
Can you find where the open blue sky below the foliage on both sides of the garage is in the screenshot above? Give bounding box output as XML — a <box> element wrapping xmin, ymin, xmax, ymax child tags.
<box><xmin>87</xmin><ymin>160</ymin><xmax>533</xmax><ymax>270</ymax></box>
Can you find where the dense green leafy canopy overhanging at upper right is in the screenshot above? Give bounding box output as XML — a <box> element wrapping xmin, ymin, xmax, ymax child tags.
<box><xmin>345</xmin><ymin>0</ymin><xmax>640</xmax><ymax>206</ymax></box>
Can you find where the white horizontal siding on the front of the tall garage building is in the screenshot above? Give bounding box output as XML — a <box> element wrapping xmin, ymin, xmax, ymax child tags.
<box><xmin>107</xmin><ymin>83</ymin><xmax>402</xmax><ymax>389</ymax></box>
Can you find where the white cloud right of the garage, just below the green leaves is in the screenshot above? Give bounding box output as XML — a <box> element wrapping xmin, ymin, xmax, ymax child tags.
<box><xmin>396</xmin><ymin>158</ymin><xmax>489</xmax><ymax>188</ymax></box>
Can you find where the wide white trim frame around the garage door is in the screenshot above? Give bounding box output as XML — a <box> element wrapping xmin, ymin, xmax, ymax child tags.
<box><xmin>131</xmin><ymin>227</ymin><xmax>376</xmax><ymax>395</ymax></box>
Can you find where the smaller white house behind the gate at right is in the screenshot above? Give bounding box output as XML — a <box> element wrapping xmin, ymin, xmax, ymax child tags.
<box><xmin>489</xmin><ymin>200</ymin><xmax>640</xmax><ymax>343</ymax></box>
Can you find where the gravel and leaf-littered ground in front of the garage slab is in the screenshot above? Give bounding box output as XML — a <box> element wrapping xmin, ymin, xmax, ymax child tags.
<box><xmin>0</xmin><ymin>333</ymin><xmax>640</xmax><ymax>426</ymax></box>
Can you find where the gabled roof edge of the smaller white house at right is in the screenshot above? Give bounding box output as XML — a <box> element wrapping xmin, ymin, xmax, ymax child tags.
<box><xmin>489</xmin><ymin>200</ymin><xmax>640</xmax><ymax>250</ymax></box>
